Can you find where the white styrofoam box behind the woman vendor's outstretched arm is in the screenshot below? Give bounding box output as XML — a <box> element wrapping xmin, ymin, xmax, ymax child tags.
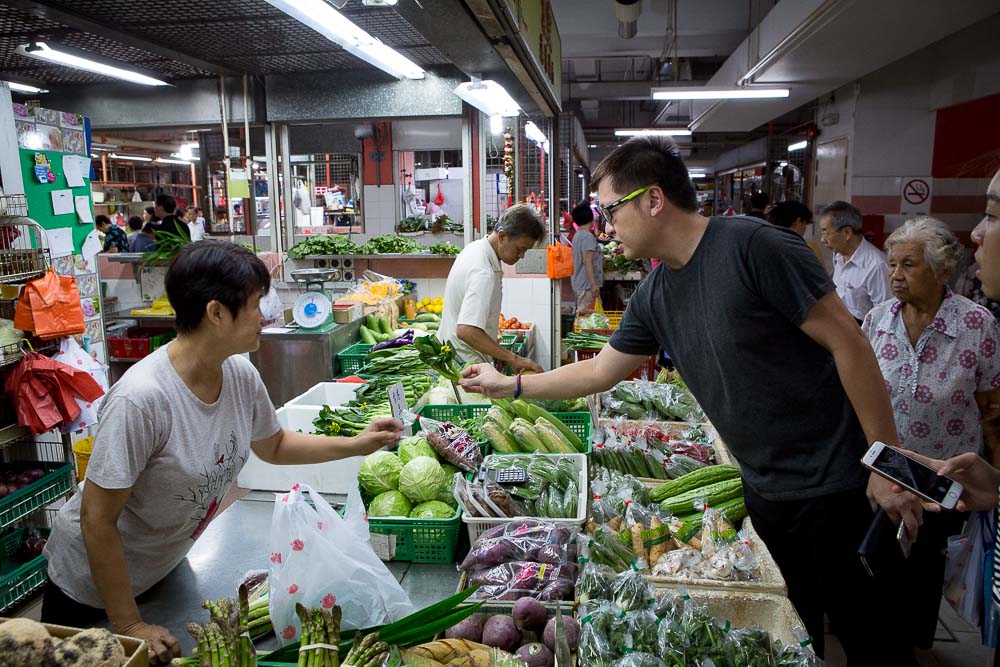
<box><xmin>237</xmin><ymin>404</ymin><xmax>364</xmax><ymax>495</ymax></box>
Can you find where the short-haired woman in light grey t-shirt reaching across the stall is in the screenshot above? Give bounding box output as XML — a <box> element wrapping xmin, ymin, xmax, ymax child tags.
<box><xmin>42</xmin><ymin>241</ymin><xmax>402</xmax><ymax>662</ymax></box>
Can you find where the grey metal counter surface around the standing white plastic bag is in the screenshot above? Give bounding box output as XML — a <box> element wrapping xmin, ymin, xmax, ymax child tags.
<box><xmin>112</xmin><ymin>493</ymin><xmax>459</xmax><ymax>655</ymax></box>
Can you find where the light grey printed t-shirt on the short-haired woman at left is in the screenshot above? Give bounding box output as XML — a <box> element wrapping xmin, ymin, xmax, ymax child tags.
<box><xmin>45</xmin><ymin>346</ymin><xmax>280</xmax><ymax>608</ymax></box>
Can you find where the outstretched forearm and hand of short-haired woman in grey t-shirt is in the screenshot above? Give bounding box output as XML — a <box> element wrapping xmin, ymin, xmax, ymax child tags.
<box><xmin>250</xmin><ymin>419</ymin><xmax>403</xmax><ymax>465</ymax></box>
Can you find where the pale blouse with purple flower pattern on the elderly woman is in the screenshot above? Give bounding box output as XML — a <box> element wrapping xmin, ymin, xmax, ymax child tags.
<box><xmin>862</xmin><ymin>289</ymin><xmax>1000</xmax><ymax>459</ymax></box>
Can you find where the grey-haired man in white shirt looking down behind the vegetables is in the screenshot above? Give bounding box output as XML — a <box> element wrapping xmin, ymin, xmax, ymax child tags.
<box><xmin>438</xmin><ymin>204</ymin><xmax>545</xmax><ymax>373</ymax></box>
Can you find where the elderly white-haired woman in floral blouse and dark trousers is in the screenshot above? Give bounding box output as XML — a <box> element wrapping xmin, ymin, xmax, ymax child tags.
<box><xmin>862</xmin><ymin>217</ymin><xmax>1000</xmax><ymax>648</ymax></box>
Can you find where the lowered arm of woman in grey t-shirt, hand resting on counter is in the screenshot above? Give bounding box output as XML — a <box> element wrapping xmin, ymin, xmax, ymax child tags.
<box><xmin>80</xmin><ymin>479</ymin><xmax>180</xmax><ymax>663</ymax></box>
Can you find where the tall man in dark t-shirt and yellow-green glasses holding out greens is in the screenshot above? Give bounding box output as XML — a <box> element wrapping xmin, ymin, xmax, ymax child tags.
<box><xmin>462</xmin><ymin>137</ymin><xmax>922</xmax><ymax>666</ymax></box>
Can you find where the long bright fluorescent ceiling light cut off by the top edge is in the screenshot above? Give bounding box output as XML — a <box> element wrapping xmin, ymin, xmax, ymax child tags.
<box><xmin>267</xmin><ymin>0</ymin><xmax>425</xmax><ymax>79</ymax></box>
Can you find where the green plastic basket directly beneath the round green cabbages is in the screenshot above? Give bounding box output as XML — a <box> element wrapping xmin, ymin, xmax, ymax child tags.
<box><xmin>366</xmin><ymin>501</ymin><xmax>462</xmax><ymax>563</ymax></box>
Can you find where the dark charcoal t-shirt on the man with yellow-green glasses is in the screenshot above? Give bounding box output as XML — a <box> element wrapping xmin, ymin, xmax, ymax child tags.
<box><xmin>611</xmin><ymin>217</ymin><xmax>868</xmax><ymax>500</ymax></box>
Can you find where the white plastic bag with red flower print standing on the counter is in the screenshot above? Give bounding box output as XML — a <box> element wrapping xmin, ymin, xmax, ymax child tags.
<box><xmin>268</xmin><ymin>484</ymin><xmax>414</xmax><ymax>644</ymax></box>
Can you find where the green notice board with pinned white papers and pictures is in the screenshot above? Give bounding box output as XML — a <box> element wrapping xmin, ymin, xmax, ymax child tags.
<box><xmin>14</xmin><ymin>104</ymin><xmax>94</xmax><ymax>253</ymax></box>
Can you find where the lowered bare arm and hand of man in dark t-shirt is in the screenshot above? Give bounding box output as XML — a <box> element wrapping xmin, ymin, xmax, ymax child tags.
<box><xmin>801</xmin><ymin>292</ymin><xmax>923</xmax><ymax>536</ymax></box>
